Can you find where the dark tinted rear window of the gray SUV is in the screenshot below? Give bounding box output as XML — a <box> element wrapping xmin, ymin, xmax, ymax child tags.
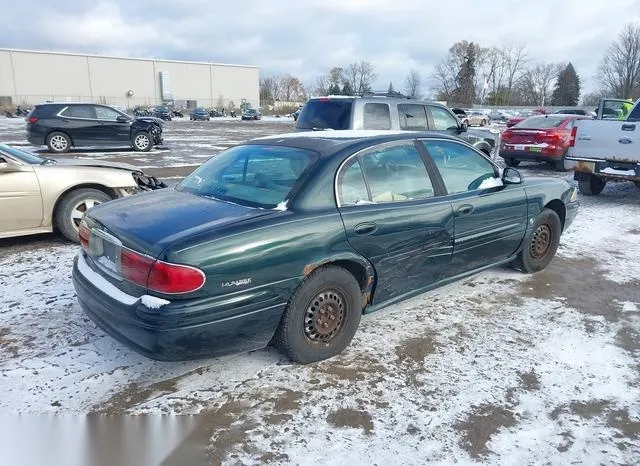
<box><xmin>296</xmin><ymin>99</ymin><xmax>353</xmax><ymax>130</ymax></box>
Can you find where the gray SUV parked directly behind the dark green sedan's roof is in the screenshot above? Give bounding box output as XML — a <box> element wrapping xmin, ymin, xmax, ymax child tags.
<box><xmin>294</xmin><ymin>95</ymin><xmax>495</xmax><ymax>156</ymax></box>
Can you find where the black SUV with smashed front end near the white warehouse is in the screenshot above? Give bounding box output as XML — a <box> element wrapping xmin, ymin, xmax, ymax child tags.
<box><xmin>27</xmin><ymin>103</ymin><xmax>162</xmax><ymax>153</ymax></box>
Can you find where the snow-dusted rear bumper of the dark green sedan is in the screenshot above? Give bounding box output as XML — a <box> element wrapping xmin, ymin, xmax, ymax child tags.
<box><xmin>72</xmin><ymin>251</ymin><xmax>285</xmax><ymax>361</ymax></box>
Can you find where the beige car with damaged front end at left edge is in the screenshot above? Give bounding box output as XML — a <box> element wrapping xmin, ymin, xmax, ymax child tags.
<box><xmin>0</xmin><ymin>144</ymin><xmax>166</xmax><ymax>242</ymax></box>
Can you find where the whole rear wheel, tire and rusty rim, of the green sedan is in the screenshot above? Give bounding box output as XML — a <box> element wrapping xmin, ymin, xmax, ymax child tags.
<box><xmin>274</xmin><ymin>265</ymin><xmax>362</xmax><ymax>364</ymax></box>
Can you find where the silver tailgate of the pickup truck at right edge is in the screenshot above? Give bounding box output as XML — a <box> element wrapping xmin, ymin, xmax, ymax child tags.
<box><xmin>568</xmin><ymin>120</ymin><xmax>640</xmax><ymax>162</ymax></box>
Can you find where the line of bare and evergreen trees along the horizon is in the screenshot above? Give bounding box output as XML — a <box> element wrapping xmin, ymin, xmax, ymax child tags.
<box><xmin>260</xmin><ymin>23</ymin><xmax>640</xmax><ymax>106</ymax></box>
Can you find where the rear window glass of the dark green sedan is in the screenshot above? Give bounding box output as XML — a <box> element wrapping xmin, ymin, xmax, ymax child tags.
<box><xmin>176</xmin><ymin>144</ymin><xmax>317</xmax><ymax>208</ymax></box>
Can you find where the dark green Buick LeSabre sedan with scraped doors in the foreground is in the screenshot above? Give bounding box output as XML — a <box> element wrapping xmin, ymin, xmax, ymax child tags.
<box><xmin>73</xmin><ymin>131</ymin><xmax>578</xmax><ymax>363</ymax></box>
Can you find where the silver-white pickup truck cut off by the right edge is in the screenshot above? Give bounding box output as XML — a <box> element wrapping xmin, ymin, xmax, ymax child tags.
<box><xmin>564</xmin><ymin>99</ymin><xmax>640</xmax><ymax>195</ymax></box>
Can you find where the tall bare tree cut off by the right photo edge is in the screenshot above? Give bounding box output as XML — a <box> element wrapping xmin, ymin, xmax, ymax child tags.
<box><xmin>599</xmin><ymin>23</ymin><xmax>640</xmax><ymax>99</ymax></box>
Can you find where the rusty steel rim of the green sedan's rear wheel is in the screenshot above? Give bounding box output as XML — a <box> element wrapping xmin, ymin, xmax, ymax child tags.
<box><xmin>304</xmin><ymin>289</ymin><xmax>346</xmax><ymax>343</ymax></box>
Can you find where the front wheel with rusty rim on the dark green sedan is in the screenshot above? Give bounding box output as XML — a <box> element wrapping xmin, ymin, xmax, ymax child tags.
<box><xmin>513</xmin><ymin>208</ymin><xmax>562</xmax><ymax>273</ymax></box>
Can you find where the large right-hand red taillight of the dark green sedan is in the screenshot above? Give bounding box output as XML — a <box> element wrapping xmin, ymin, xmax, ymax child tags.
<box><xmin>120</xmin><ymin>249</ymin><xmax>205</xmax><ymax>294</ymax></box>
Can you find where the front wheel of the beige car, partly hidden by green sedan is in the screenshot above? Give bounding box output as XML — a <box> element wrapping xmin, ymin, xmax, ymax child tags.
<box><xmin>54</xmin><ymin>188</ymin><xmax>112</xmax><ymax>243</ymax></box>
